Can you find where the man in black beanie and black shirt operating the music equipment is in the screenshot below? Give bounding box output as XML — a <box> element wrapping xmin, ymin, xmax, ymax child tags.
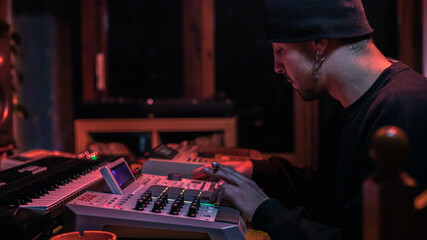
<box><xmin>193</xmin><ymin>0</ymin><xmax>427</xmax><ymax>239</ymax></box>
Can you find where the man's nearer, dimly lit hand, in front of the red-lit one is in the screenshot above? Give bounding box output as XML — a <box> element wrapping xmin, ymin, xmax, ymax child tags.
<box><xmin>202</xmin><ymin>162</ymin><xmax>269</xmax><ymax>220</ymax></box>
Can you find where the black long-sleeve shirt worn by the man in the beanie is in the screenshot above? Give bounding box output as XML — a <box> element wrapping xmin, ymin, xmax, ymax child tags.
<box><xmin>252</xmin><ymin>61</ymin><xmax>427</xmax><ymax>240</ymax></box>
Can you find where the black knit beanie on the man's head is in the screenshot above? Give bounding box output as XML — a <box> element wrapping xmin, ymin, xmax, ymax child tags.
<box><xmin>264</xmin><ymin>0</ymin><xmax>373</xmax><ymax>42</ymax></box>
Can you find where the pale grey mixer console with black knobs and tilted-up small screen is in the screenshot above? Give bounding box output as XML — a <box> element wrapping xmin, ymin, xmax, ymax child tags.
<box><xmin>65</xmin><ymin>158</ymin><xmax>246</xmax><ymax>239</ymax></box>
